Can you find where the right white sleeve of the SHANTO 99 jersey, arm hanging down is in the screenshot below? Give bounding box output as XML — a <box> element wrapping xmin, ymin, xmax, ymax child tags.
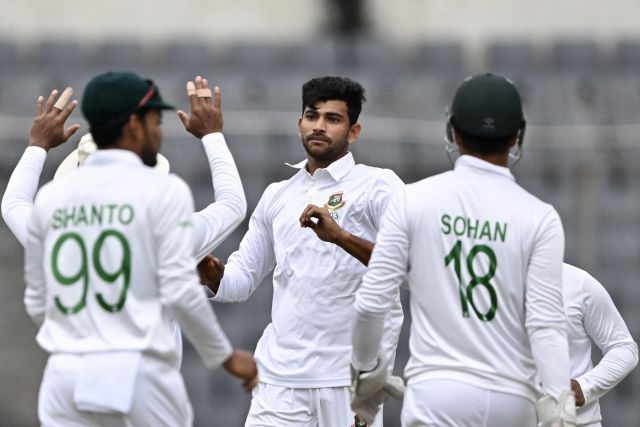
<box><xmin>151</xmin><ymin>177</ymin><xmax>233</xmax><ymax>368</ymax></box>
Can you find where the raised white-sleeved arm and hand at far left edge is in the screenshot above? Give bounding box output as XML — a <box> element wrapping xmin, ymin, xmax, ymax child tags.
<box><xmin>2</xmin><ymin>88</ymin><xmax>80</xmax><ymax>246</ymax></box>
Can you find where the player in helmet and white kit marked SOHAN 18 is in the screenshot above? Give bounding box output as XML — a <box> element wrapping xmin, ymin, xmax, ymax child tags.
<box><xmin>353</xmin><ymin>74</ymin><xmax>575</xmax><ymax>427</ymax></box>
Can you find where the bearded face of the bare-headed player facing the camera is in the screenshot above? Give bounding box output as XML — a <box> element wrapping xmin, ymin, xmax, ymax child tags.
<box><xmin>298</xmin><ymin>100</ymin><xmax>360</xmax><ymax>162</ymax></box>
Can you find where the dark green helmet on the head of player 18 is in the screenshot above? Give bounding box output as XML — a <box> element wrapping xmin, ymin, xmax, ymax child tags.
<box><xmin>449</xmin><ymin>73</ymin><xmax>525</xmax><ymax>138</ymax></box>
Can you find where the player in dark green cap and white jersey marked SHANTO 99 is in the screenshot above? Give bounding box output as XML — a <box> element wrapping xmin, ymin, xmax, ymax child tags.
<box><xmin>25</xmin><ymin>72</ymin><xmax>257</xmax><ymax>427</ymax></box>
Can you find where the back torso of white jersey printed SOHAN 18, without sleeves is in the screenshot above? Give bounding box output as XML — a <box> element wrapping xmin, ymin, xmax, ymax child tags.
<box><xmin>404</xmin><ymin>156</ymin><xmax>561</xmax><ymax>398</ymax></box>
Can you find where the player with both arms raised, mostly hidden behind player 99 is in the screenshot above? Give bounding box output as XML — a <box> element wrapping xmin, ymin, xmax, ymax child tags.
<box><xmin>2</xmin><ymin>76</ymin><xmax>247</xmax><ymax>366</ymax></box>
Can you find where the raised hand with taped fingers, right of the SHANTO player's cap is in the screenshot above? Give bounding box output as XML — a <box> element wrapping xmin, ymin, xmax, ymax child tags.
<box><xmin>178</xmin><ymin>76</ymin><xmax>222</xmax><ymax>139</ymax></box>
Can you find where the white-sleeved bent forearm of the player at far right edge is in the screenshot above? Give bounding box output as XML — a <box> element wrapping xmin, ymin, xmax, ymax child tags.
<box><xmin>576</xmin><ymin>342</ymin><xmax>638</xmax><ymax>403</ymax></box>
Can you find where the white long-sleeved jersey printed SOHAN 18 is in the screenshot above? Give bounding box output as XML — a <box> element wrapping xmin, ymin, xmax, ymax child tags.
<box><xmin>354</xmin><ymin>156</ymin><xmax>569</xmax><ymax>401</ymax></box>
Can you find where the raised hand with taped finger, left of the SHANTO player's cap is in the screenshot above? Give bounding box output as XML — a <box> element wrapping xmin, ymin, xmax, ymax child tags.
<box><xmin>29</xmin><ymin>87</ymin><xmax>80</xmax><ymax>151</ymax></box>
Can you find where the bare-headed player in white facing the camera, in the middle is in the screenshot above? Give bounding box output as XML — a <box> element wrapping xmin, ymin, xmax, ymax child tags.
<box><xmin>200</xmin><ymin>77</ymin><xmax>402</xmax><ymax>427</ymax></box>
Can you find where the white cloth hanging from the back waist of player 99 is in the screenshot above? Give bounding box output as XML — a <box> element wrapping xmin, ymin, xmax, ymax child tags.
<box><xmin>73</xmin><ymin>351</ymin><xmax>142</xmax><ymax>414</ymax></box>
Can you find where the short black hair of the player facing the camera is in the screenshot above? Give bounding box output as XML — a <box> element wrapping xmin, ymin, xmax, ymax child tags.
<box><xmin>302</xmin><ymin>76</ymin><xmax>366</xmax><ymax>125</ymax></box>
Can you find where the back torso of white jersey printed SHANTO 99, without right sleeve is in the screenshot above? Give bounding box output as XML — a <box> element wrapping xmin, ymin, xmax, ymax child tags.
<box><xmin>26</xmin><ymin>150</ymin><xmax>190</xmax><ymax>358</ymax></box>
